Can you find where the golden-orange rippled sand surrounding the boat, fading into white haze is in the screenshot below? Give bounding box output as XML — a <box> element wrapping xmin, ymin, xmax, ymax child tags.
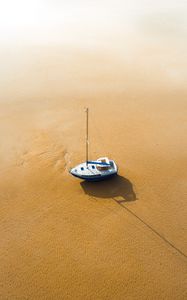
<box><xmin>0</xmin><ymin>43</ymin><xmax>187</xmax><ymax>300</ymax></box>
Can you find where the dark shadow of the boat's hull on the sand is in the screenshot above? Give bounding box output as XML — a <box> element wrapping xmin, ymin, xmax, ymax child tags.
<box><xmin>80</xmin><ymin>175</ymin><xmax>137</xmax><ymax>204</ymax></box>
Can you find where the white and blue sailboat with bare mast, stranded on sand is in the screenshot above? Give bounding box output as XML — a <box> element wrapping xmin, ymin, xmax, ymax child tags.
<box><xmin>70</xmin><ymin>108</ymin><xmax>118</xmax><ymax>181</ymax></box>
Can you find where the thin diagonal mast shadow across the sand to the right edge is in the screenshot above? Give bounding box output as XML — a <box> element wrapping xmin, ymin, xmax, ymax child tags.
<box><xmin>112</xmin><ymin>198</ymin><xmax>187</xmax><ymax>258</ymax></box>
